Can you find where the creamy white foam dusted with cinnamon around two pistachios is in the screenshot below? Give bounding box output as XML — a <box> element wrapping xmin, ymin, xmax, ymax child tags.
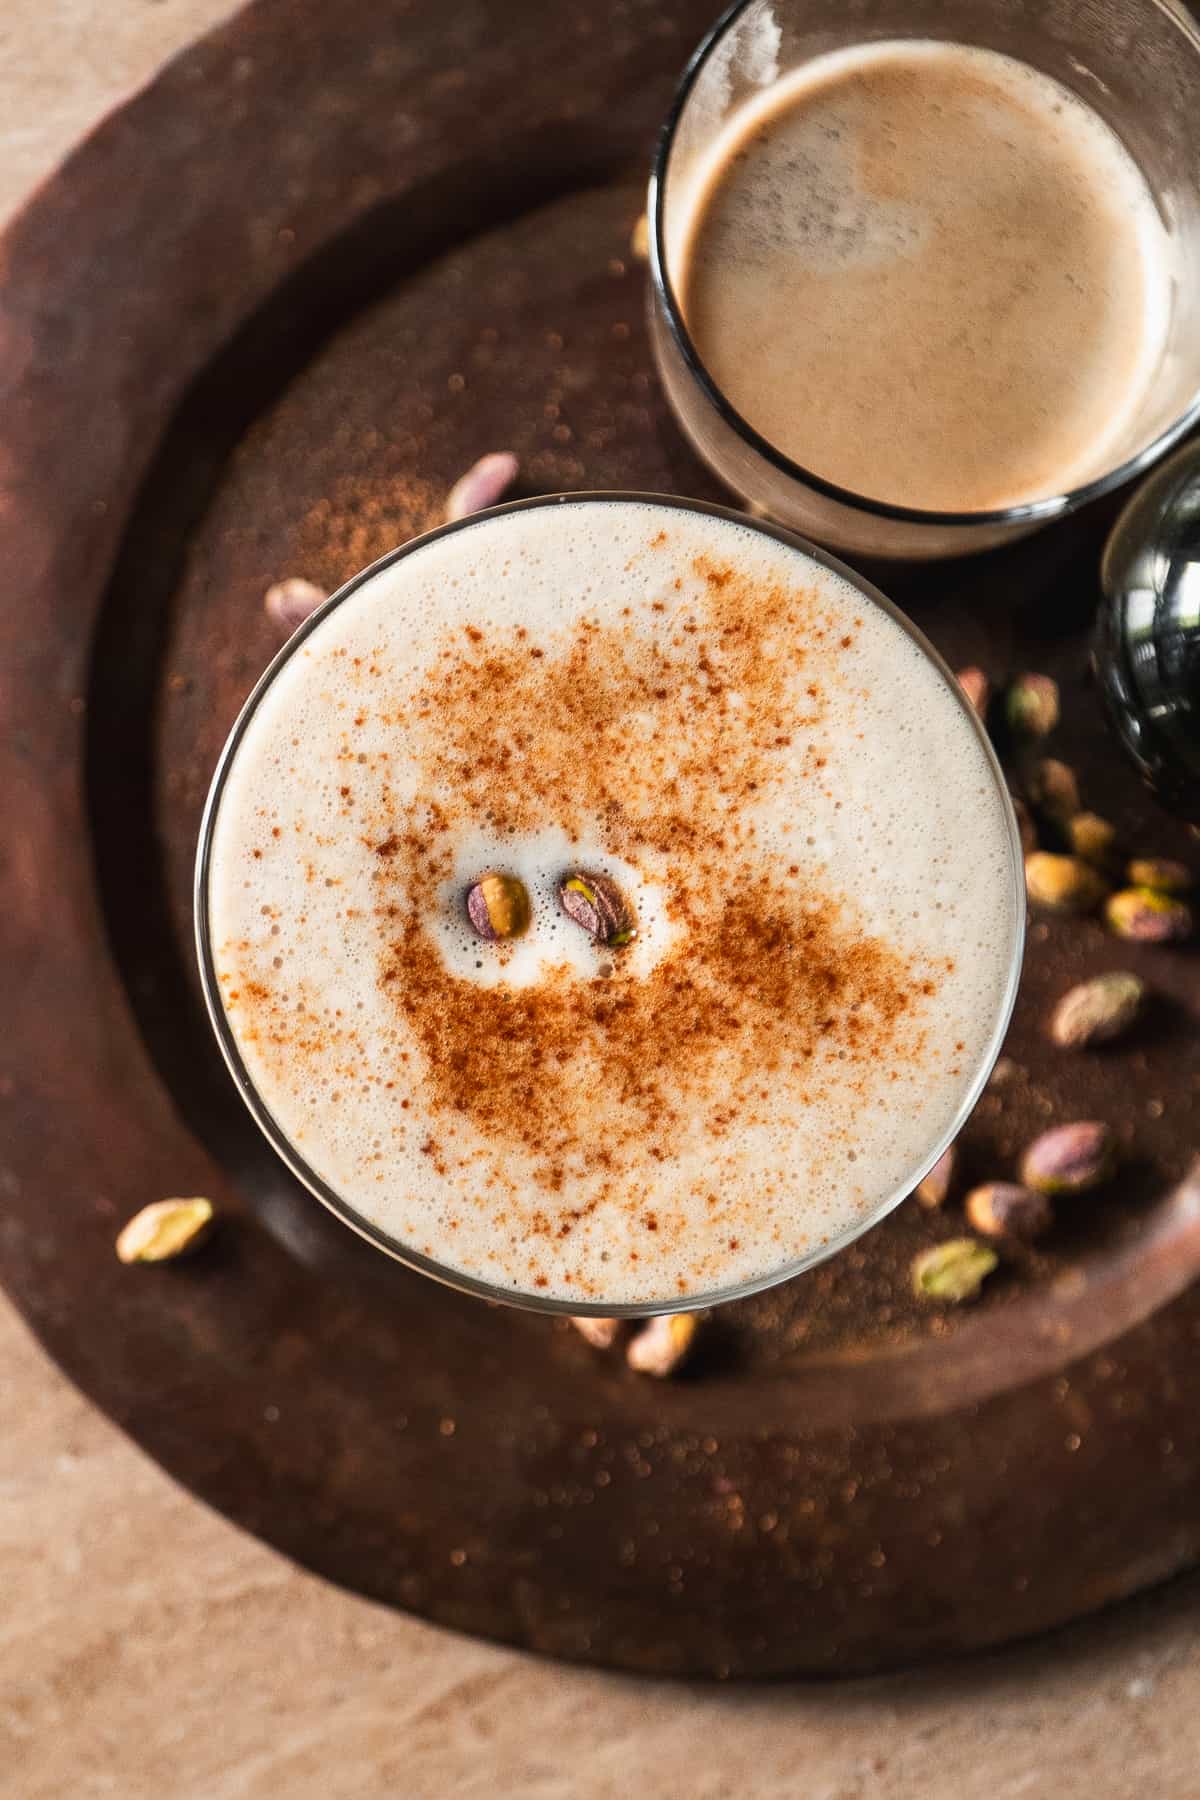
<box><xmin>209</xmin><ymin>500</ymin><xmax>1018</xmax><ymax>1305</ymax></box>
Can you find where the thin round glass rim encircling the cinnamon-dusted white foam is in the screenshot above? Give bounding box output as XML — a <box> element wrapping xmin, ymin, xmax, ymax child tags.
<box><xmin>193</xmin><ymin>490</ymin><xmax>1025</xmax><ymax>1319</ymax></box>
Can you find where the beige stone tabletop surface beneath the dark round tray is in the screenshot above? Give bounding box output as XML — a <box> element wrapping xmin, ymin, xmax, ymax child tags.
<box><xmin>0</xmin><ymin>0</ymin><xmax>1200</xmax><ymax>1800</ymax></box>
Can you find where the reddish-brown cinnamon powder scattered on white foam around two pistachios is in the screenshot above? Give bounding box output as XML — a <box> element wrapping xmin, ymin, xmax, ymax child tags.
<box><xmin>218</xmin><ymin>533</ymin><xmax>934</xmax><ymax>1291</ymax></box>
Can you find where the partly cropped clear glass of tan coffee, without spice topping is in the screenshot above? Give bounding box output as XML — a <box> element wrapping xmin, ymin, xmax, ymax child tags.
<box><xmin>649</xmin><ymin>0</ymin><xmax>1200</xmax><ymax>556</ymax></box>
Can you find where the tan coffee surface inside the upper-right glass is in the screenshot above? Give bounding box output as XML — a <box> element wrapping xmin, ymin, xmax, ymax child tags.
<box><xmin>673</xmin><ymin>41</ymin><xmax>1171</xmax><ymax>511</ymax></box>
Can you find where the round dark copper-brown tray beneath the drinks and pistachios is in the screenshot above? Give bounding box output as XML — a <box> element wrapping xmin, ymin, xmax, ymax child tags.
<box><xmin>0</xmin><ymin>0</ymin><xmax>1200</xmax><ymax>1676</ymax></box>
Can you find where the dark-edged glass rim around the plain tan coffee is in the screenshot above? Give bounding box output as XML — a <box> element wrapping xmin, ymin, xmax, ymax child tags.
<box><xmin>646</xmin><ymin>0</ymin><xmax>1200</xmax><ymax>527</ymax></box>
